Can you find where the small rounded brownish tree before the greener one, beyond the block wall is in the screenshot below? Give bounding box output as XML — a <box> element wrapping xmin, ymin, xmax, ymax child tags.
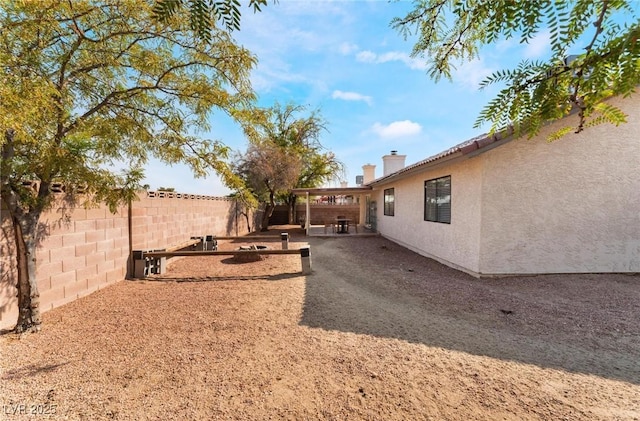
<box><xmin>235</xmin><ymin>138</ymin><xmax>302</xmax><ymax>231</ymax></box>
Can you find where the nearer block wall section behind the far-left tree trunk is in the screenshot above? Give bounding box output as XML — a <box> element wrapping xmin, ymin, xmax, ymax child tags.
<box><xmin>0</xmin><ymin>200</ymin><xmax>129</xmax><ymax>328</ymax></box>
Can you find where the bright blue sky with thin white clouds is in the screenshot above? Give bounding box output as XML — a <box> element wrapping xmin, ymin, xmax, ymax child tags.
<box><xmin>140</xmin><ymin>0</ymin><xmax>568</xmax><ymax>196</ymax></box>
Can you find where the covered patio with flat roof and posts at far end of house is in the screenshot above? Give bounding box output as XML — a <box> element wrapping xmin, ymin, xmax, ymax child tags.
<box><xmin>291</xmin><ymin>186</ymin><xmax>377</xmax><ymax>237</ymax></box>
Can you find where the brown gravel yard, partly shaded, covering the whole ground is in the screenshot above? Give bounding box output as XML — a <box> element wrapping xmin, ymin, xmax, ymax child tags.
<box><xmin>0</xmin><ymin>231</ymin><xmax>640</xmax><ymax>421</ymax></box>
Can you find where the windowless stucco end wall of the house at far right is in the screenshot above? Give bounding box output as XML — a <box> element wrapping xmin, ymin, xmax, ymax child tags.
<box><xmin>478</xmin><ymin>95</ymin><xmax>640</xmax><ymax>274</ymax></box>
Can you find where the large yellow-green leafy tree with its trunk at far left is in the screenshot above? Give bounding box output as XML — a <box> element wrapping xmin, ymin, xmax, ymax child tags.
<box><xmin>0</xmin><ymin>0</ymin><xmax>255</xmax><ymax>331</ymax></box>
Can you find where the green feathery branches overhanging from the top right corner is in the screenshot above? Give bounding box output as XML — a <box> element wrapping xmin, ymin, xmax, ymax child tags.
<box><xmin>392</xmin><ymin>0</ymin><xmax>640</xmax><ymax>139</ymax></box>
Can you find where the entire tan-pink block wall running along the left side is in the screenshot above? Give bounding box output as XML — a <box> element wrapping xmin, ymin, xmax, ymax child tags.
<box><xmin>0</xmin><ymin>192</ymin><xmax>255</xmax><ymax>328</ymax></box>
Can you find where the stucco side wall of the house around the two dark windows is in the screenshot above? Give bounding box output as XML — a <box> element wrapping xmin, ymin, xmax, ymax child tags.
<box><xmin>374</xmin><ymin>158</ymin><xmax>482</xmax><ymax>272</ymax></box>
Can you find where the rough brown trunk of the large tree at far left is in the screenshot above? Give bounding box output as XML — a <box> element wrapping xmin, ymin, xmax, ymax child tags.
<box><xmin>11</xmin><ymin>212</ymin><xmax>42</xmax><ymax>333</ymax></box>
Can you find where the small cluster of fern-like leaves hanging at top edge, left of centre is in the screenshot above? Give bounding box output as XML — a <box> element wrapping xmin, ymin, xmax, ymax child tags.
<box><xmin>153</xmin><ymin>0</ymin><xmax>267</xmax><ymax>41</ymax></box>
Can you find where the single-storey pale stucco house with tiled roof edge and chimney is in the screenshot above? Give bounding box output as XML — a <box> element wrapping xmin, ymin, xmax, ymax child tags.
<box><xmin>362</xmin><ymin>95</ymin><xmax>640</xmax><ymax>276</ymax></box>
